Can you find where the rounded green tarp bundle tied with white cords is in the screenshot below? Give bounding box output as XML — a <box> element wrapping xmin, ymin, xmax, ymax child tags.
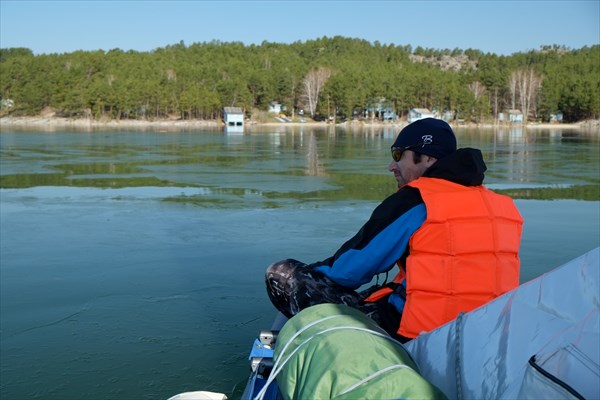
<box><xmin>273</xmin><ymin>304</ymin><xmax>445</xmax><ymax>400</ymax></box>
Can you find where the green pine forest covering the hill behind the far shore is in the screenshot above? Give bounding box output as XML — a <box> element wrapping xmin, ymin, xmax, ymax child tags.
<box><xmin>0</xmin><ymin>36</ymin><xmax>600</xmax><ymax>122</ymax></box>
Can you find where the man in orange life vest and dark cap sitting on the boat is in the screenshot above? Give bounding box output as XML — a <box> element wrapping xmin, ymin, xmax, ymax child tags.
<box><xmin>266</xmin><ymin>118</ymin><xmax>523</xmax><ymax>341</ymax></box>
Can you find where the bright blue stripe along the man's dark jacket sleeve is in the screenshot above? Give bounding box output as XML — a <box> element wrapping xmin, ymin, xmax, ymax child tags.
<box><xmin>315</xmin><ymin>204</ymin><xmax>427</xmax><ymax>289</ymax></box>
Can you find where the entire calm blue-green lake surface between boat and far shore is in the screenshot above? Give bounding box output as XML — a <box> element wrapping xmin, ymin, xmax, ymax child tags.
<box><xmin>0</xmin><ymin>126</ymin><xmax>600</xmax><ymax>400</ymax></box>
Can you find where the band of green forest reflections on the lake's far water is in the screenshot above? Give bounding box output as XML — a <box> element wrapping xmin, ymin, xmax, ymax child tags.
<box><xmin>0</xmin><ymin>126</ymin><xmax>599</xmax><ymax>200</ymax></box>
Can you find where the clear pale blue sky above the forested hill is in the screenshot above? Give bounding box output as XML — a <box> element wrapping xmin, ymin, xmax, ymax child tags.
<box><xmin>0</xmin><ymin>0</ymin><xmax>600</xmax><ymax>55</ymax></box>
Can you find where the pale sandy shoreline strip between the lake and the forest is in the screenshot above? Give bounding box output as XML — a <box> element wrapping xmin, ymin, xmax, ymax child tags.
<box><xmin>0</xmin><ymin>117</ymin><xmax>600</xmax><ymax>133</ymax></box>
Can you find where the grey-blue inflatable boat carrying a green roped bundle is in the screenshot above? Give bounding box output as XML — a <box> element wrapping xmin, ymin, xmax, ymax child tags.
<box><xmin>170</xmin><ymin>247</ymin><xmax>600</xmax><ymax>400</ymax></box>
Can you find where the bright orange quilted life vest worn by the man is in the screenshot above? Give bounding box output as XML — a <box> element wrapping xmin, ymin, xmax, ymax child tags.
<box><xmin>366</xmin><ymin>177</ymin><xmax>523</xmax><ymax>338</ymax></box>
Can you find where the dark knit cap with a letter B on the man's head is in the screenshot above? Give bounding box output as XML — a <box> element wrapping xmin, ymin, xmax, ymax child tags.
<box><xmin>392</xmin><ymin>118</ymin><xmax>456</xmax><ymax>159</ymax></box>
